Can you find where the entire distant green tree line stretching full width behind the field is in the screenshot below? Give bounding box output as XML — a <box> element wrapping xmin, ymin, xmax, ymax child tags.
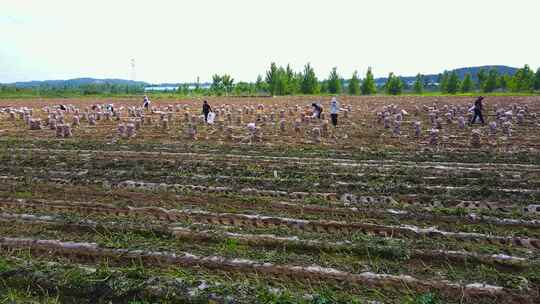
<box><xmin>0</xmin><ymin>63</ymin><xmax>540</xmax><ymax>96</ymax></box>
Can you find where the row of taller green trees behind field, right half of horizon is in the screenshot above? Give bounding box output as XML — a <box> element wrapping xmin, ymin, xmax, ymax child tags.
<box><xmin>257</xmin><ymin>63</ymin><xmax>540</xmax><ymax>95</ymax></box>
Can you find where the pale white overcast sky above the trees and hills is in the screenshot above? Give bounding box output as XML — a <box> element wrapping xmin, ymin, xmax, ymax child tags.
<box><xmin>0</xmin><ymin>0</ymin><xmax>540</xmax><ymax>83</ymax></box>
